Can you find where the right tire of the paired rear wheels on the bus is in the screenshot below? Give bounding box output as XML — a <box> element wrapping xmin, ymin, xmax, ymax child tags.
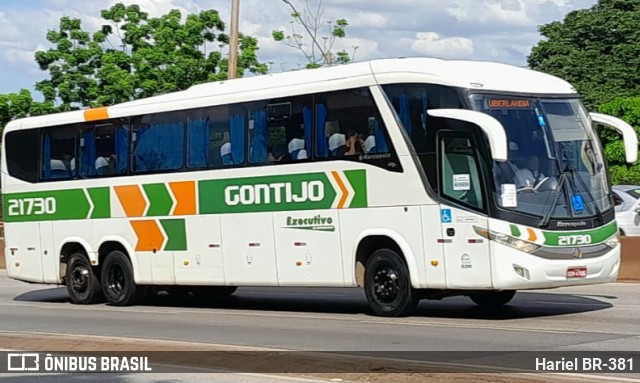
<box><xmin>102</xmin><ymin>250</ymin><xmax>146</xmax><ymax>306</ymax></box>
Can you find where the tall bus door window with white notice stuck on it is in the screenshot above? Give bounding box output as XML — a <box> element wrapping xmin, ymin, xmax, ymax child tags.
<box><xmin>440</xmin><ymin>134</ymin><xmax>484</xmax><ymax>210</ymax></box>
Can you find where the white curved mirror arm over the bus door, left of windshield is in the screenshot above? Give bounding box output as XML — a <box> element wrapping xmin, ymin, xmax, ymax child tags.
<box><xmin>427</xmin><ymin>109</ymin><xmax>508</xmax><ymax>162</ymax></box>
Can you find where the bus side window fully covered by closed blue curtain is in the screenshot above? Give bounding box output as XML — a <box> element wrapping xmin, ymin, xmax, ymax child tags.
<box><xmin>132</xmin><ymin>112</ymin><xmax>185</xmax><ymax>173</ymax></box>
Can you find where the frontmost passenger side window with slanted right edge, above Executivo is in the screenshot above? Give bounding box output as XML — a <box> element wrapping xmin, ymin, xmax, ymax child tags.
<box><xmin>316</xmin><ymin>88</ymin><xmax>390</xmax><ymax>157</ymax></box>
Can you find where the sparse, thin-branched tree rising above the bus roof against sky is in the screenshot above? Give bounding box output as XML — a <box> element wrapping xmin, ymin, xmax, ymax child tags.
<box><xmin>271</xmin><ymin>0</ymin><xmax>358</xmax><ymax>68</ymax></box>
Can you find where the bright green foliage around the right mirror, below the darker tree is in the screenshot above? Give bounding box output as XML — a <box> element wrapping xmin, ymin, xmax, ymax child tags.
<box><xmin>598</xmin><ymin>96</ymin><xmax>640</xmax><ymax>185</ymax></box>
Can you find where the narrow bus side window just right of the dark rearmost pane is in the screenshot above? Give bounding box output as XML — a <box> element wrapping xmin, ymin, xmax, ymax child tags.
<box><xmin>42</xmin><ymin>126</ymin><xmax>78</xmax><ymax>181</ymax></box>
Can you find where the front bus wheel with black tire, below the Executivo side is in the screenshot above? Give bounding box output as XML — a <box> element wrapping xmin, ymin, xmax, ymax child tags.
<box><xmin>364</xmin><ymin>249</ymin><xmax>418</xmax><ymax>317</ymax></box>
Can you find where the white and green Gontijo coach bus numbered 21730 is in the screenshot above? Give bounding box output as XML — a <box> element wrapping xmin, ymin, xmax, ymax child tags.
<box><xmin>2</xmin><ymin>58</ymin><xmax>638</xmax><ymax>316</ymax></box>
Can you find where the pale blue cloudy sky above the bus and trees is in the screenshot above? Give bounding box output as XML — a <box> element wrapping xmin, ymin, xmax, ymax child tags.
<box><xmin>0</xmin><ymin>0</ymin><xmax>596</xmax><ymax>93</ymax></box>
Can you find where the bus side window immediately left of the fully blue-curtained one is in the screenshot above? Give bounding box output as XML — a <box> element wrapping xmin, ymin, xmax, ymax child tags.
<box><xmin>80</xmin><ymin>120</ymin><xmax>129</xmax><ymax>177</ymax></box>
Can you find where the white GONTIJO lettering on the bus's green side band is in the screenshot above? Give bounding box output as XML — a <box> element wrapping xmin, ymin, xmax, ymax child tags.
<box><xmin>224</xmin><ymin>181</ymin><xmax>324</xmax><ymax>206</ymax></box>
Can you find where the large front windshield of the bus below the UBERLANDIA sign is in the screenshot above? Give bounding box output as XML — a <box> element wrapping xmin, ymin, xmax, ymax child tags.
<box><xmin>471</xmin><ymin>94</ymin><xmax>611</xmax><ymax>226</ymax></box>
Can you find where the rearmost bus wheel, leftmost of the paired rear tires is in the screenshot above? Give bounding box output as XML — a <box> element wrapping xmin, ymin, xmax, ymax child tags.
<box><xmin>65</xmin><ymin>253</ymin><xmax>102</xmax><ymax>305</ymax></box>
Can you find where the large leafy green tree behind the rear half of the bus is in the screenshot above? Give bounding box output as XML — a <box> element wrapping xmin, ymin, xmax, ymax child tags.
<box><xmin>36</xmin><ymin>3</ymin><xmax>267</xmax><ymax>110</ymax></box>
